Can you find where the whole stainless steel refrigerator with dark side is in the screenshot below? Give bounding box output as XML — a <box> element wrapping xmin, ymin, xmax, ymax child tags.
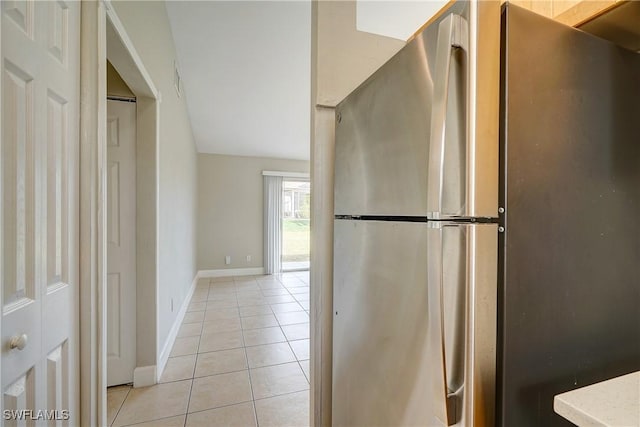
<box><xmin>332</xmin><ymin>1</ymin><xmax>640</xmax><ymax>427</ymax></box>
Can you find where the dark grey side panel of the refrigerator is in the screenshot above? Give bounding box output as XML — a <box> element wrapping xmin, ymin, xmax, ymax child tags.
<box><xmin>499</xmin><ymin>5</ymin><xmax>640</xmax><ymax>427</ymax></box>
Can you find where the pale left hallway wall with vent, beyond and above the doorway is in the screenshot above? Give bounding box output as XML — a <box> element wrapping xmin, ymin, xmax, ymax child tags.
<box><xmin>111</xmin><ymin>1</ymin><xmax>197</xmax><ymax>362</ymax></box>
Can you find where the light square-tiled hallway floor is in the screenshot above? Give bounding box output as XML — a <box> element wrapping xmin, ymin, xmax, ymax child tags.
<box><xmin>107</xmin><ymin>272</ymin><xmax>309</xmax><ymax>427</ymax></box>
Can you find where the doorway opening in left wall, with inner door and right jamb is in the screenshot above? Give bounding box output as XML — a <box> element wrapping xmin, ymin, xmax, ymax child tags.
<box><xmin>100</xmin><ymin>0</ymin><xmax>161</xmax><ymax>408</ymax></box>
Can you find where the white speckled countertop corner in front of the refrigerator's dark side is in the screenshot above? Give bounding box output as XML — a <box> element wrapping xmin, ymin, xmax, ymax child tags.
<box><xmin>553</xmin><ymin>371</ymin><xmax>640</xmax><ymax>427</ymax></box>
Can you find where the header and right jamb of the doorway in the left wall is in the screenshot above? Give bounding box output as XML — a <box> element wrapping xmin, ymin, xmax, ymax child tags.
<box><xmin>106</xmin><ymin>2</ymin><xmax>160</xmax><ymax>387</ymax></box>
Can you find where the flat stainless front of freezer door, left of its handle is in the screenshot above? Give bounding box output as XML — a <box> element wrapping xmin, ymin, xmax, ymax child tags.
<box><xmin>334</xmin><ymin>26</ymin><xmax>434</xmax><ymax>216</ymax></box>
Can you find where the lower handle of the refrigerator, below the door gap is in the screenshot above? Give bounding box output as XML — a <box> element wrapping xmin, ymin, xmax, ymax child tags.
<box><xmin>427</xmin><ymin>223</ymin><xmax>457</xmax><ymax>426</ymax></box>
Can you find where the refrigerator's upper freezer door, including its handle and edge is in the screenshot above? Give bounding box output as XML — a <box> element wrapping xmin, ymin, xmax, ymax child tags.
<box><xmin>335</xmin><ymin>1</ymin><xmax>499</xmax><ymax>218</ymax></box>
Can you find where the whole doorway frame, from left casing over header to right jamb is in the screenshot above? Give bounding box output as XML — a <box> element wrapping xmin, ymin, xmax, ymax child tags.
<box><xmin>80</xmin><ymin>0</ymin><xmax>160</xmax><ymax>425</ymax></box>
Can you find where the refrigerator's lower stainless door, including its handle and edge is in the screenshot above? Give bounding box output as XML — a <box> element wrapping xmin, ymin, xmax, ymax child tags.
<box><xmin>332</xmin><ymin>220</ymin><xmax>497</xmax><ymax>426</ymax></box>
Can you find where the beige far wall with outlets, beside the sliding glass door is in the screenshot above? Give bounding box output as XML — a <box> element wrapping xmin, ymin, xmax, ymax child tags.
<box><xmin>197</xmin><ymin>154</ymin><xmax>309</xmax><ymax>270</ymax></box>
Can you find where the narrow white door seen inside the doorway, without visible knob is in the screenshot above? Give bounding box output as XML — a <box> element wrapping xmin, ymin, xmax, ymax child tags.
<box><xmin>107</xmin><ymin>100</ymin><xmax>136</xmax><ymax>386</ymax></box>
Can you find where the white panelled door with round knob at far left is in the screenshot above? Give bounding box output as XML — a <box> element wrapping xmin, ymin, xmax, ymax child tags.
<box><xmin>0</xmin><ymin>0</ymin><xmax>80</xmax><ymax>425</ymax></box>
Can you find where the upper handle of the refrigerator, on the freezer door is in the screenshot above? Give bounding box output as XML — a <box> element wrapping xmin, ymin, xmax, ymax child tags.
<box><xmin>427</xmin><ymin>14</ymin><xmax>469</xmax><ymax>219</ymax></box>
